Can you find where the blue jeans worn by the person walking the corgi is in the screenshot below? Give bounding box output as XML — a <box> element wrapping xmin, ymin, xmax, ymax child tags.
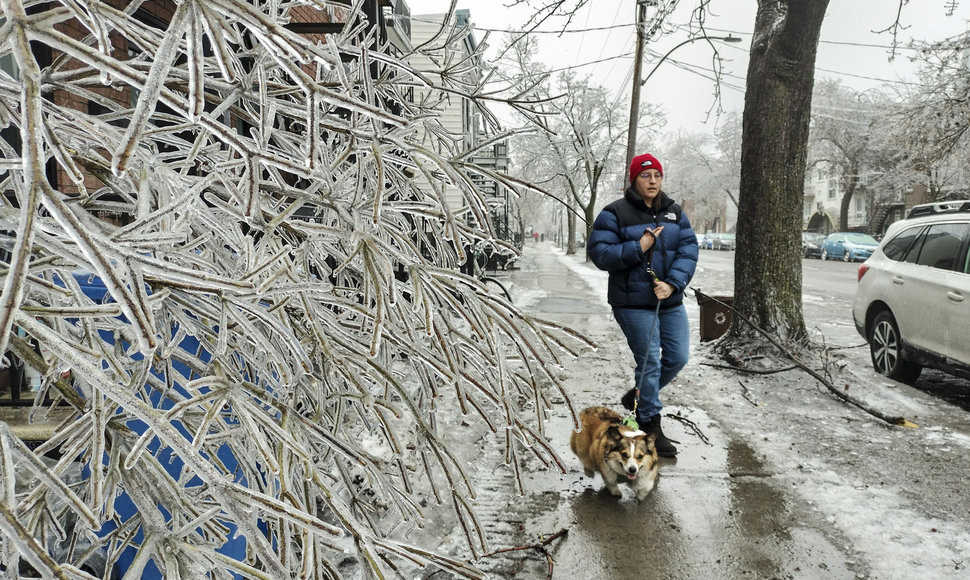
<box><xmin>613</xmin><ymin>304</ymin><xmax>690</xmax><ymax>422</ymax></box>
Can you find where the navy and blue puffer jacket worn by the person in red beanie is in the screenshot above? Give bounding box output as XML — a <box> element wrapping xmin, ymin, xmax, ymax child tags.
<box><xmin>588</xmin><ymin>187</ymin><xmax>697</xmax><ymax>308</ymax></box>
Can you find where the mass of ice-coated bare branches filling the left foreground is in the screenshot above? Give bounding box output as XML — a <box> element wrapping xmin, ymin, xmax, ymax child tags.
<box><xmin>0</xmin><ymin>0</ymin><xmax>585</xmax><ymax>579</ymax></box>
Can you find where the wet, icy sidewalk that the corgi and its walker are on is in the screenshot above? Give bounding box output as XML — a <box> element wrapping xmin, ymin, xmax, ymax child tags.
<box><xmin>454</xmin><ymin>243</ymin><xmax>856</xmax><ymax>580</ymax></box>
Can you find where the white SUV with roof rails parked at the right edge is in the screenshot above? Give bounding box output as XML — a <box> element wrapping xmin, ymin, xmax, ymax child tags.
<box><xmin>852</xmin><ymin>201</ymin><xmax>970</xmax><ymax>383</ymax></box>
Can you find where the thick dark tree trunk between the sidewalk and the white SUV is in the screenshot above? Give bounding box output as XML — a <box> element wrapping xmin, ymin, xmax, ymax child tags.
<box><xmin>725</xmin><ymin>0</ymin><xmax>828</xmax><ymax>348</ymax></box>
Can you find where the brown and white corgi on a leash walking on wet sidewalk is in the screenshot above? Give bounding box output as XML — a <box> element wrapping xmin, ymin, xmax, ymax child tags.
<box><xmin>569</xmin><ymin>407</ymin><xmax>660</xmax><ymax>500</ymax></box>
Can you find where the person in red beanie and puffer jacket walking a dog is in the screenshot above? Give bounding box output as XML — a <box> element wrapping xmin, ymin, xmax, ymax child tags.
<box><xmin>589</xmin><ymin>153</ymin><xmax>698</xmax><ymax>457</ymax></box>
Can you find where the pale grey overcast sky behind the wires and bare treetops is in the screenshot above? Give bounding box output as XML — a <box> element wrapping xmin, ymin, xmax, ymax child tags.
<box><xmin>407</xmin><ymin>0</ymin><xmax>970</xmax><ymax>139</ymax></box>
